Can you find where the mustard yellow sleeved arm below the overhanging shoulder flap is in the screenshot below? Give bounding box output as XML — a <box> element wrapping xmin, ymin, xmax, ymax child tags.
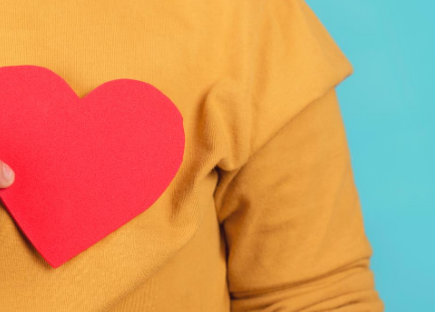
<box><xmin>215</xmin><ymin>88</ymin><xmax>384</xmax><ymax>312</ymax></box>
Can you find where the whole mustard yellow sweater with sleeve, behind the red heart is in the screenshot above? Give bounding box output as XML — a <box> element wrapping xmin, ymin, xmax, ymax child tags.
<box><xmin>0</xmin><ymin>0</ymin><xmax>384</xmax><ymax>312</ymax></box>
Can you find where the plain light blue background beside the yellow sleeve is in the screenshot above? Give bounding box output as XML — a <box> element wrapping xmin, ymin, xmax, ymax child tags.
<box><xmin>306</xmin><ymin>0</ymin><xmax>435</xmax><ymax>312</ymax></box>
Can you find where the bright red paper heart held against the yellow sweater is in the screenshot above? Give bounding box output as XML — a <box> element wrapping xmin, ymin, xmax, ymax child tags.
<box><xmin>0</xmin><ymin>65</ymin><xmax>185</xmax><ymax>268</ymax></box>
